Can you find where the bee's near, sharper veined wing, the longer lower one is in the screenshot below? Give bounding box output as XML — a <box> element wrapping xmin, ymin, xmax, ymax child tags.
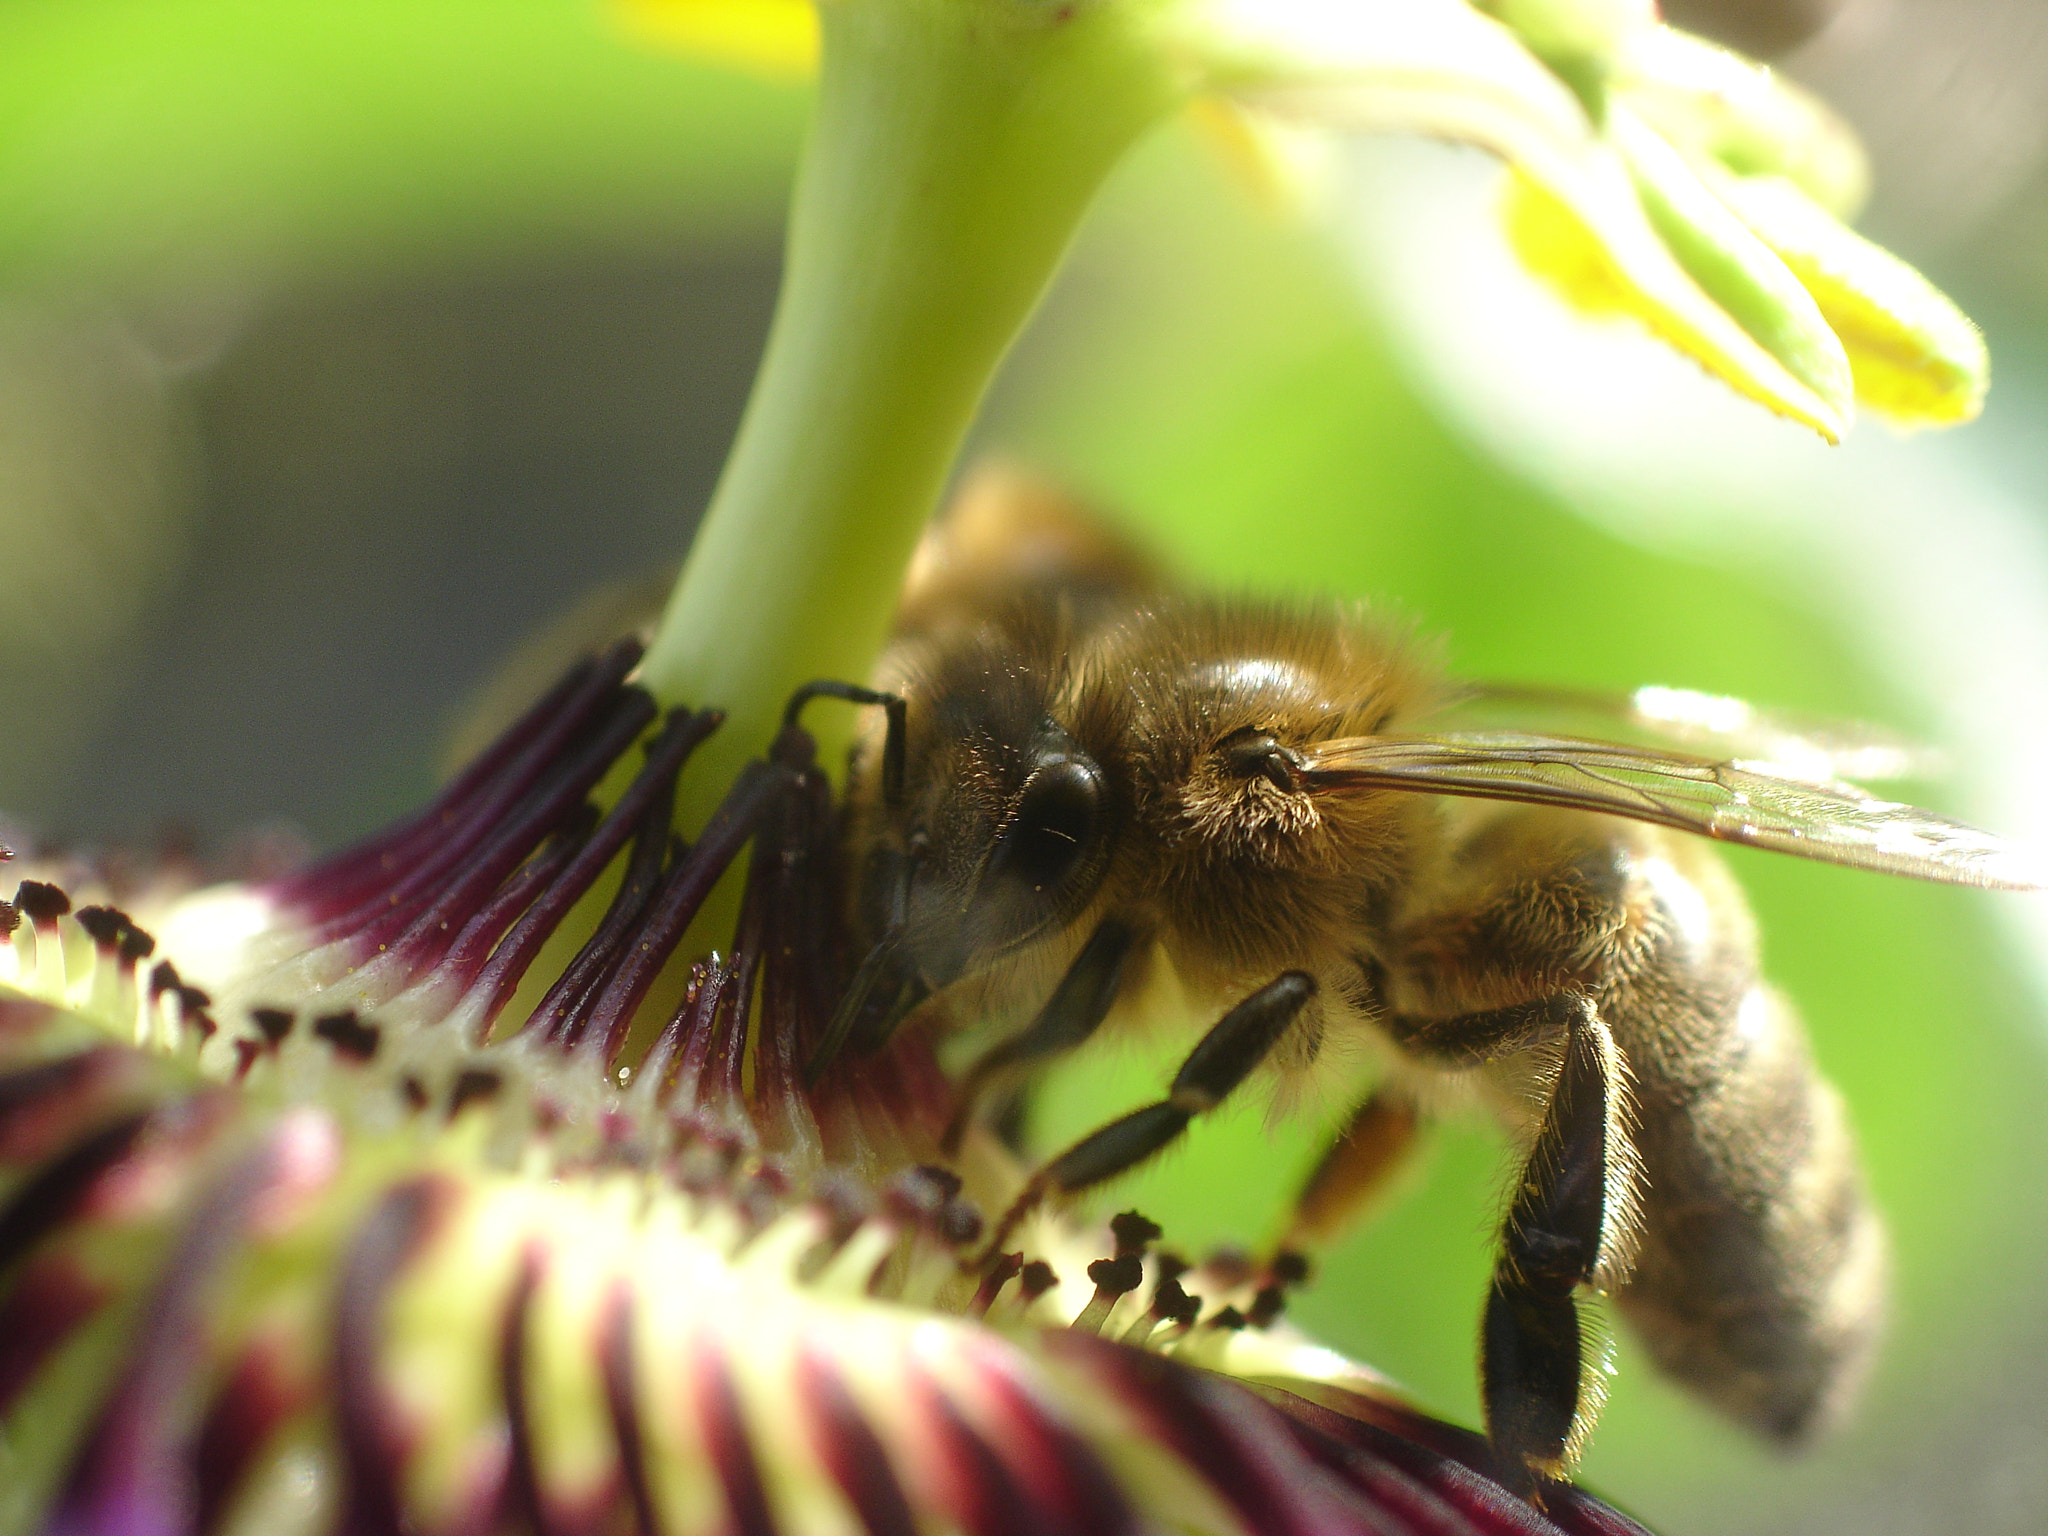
<box><xmin>1303</xmin><ymin>731</ymin><xmax>2048</xmax><ymax>891</ymax></box>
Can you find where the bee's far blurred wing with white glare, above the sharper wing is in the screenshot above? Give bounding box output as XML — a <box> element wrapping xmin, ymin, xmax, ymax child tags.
<box><xmin>1430</xmin><ymin>682</ymin><xmax>1944</xmax><ymax>784</ymax></box>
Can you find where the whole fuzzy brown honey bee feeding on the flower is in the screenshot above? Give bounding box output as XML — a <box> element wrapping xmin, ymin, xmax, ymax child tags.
<box><xmin>790</xmin><ymin>483</ymin><xmax>2042</xmax><ymax>1493</ymax></box>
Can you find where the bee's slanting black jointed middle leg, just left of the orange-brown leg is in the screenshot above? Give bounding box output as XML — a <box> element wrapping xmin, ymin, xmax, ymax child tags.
<box><xmin>985</xmin><ymin>971</ymin><xmax>1315</xmax><ymax>1255</ymax></box>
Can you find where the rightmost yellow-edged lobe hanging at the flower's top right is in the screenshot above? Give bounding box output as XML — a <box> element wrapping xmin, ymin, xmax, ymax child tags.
<box><xmin>1714</xmin><ymin>176</ymin><xmax>1991</xmax><ymax>426</ymax></box>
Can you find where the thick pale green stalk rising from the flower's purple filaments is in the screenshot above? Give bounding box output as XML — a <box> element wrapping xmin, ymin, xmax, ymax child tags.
<box><xmin>643</xmin><ymin>0</ymin><xmax>1182</xmax><ymax>827</ymax></box>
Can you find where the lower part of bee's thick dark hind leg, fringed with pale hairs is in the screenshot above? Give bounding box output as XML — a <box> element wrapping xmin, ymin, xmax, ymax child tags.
<box><xmin>1479</xmin><ymin>999</ymin><xmax>1634</xmax><ymax>1495</ymax></box>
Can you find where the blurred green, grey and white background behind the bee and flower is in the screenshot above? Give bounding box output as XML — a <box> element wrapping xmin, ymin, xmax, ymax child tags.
<box><xmin>0</xmin><ymin>0</ymin><xmax>2048</xmax><ymax>1532</ymax></box>
